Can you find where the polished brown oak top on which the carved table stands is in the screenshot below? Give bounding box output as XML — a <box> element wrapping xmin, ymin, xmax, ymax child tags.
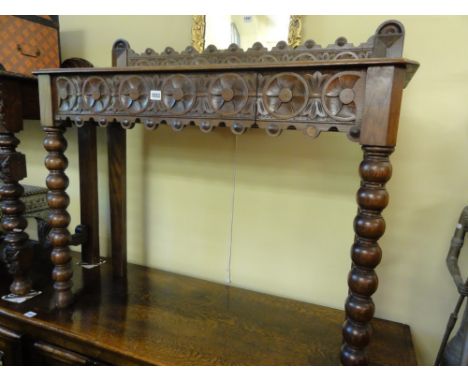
<box><xmin>0</xmin><ymin>254</ymin><xmax>416</xmax><ymax>365</ymax></box>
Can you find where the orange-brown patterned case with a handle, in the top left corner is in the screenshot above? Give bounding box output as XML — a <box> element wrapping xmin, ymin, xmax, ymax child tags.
<box><xmin>0</xmin><ymin>16</ymin><xmax>60</xmax><ymax>75</ymax></box>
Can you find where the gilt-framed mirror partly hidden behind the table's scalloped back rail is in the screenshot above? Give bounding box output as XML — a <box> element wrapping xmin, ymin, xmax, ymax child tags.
<box><xmin>192</xmin><ymin>15</ymin><xmax>302</xmax><ymax>52</ymax></box>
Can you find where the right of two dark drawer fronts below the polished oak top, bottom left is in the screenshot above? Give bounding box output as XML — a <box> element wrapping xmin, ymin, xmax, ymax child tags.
<box><xmin>31</xmin><ymin>341</ymin><xmax>101</xmax><ymax>366</ymax></box>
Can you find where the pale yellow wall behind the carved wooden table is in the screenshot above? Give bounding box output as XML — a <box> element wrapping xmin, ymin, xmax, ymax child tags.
<box><xmin>20</xmin><ymin>16</ymin><xmax>468</xmax><ymax>364</ymax></box>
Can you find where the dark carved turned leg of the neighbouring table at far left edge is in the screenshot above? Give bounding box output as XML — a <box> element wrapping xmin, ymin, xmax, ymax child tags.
<box><xmin>0</xmin><ymin>132</ymin><xmax>32</xmax><ymax>295</ymax></box>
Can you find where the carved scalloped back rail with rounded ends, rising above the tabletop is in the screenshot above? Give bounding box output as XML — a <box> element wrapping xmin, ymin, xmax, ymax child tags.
<box><xmin>119</xmin><ymin>20</ymin><xmax>405</xmax><ymax>66</ymax></box>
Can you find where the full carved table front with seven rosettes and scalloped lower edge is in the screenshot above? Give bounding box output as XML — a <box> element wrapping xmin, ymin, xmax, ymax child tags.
<box><xmin>54</xmin><ymin>69</ymin><xmax>365</xmax><ymax>139</ymax></box>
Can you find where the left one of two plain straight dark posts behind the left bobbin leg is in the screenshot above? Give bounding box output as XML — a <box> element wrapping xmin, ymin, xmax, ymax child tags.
<box><xmin>78</xmin><ymin>122</ymin><xmax>100</xmax><ymax>264</ymax></box>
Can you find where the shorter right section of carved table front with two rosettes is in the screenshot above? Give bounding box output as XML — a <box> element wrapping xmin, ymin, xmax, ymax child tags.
<box><xmin>256</xmin><ymin>70</ymin><xmax>365</xmax><ymax>138</ymax></box>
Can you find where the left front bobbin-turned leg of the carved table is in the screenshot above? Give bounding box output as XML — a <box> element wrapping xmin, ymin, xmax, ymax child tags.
<box><xmin>44</xmin><ymin>126</ymin><xmax>73</xmax><ymax>308</ymax></box>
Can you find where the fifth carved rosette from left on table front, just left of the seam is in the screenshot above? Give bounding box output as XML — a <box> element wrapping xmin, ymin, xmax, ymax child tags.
<box><xmin>208</xmin><ymin>73</ymin><xmax>249</xmax><ymax>115</ymax></box>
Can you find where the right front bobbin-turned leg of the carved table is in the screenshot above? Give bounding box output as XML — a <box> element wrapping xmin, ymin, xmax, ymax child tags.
<box><xmin>341</xmin><ymin>146</ymin><xmax>393</xmax><ymax>365</ymax></box>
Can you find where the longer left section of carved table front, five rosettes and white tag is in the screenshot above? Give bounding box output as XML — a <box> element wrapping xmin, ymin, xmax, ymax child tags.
<box><xmin>54</xmin><ymin>73</ymin><xmax>257</xmax><ymax>127</ymax></box>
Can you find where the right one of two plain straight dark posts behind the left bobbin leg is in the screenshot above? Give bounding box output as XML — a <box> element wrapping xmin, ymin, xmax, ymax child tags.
<box><xmin>107</xmin><ymin>123</ymin><xmax>127</xmax><ymax>278</ymax></box>
